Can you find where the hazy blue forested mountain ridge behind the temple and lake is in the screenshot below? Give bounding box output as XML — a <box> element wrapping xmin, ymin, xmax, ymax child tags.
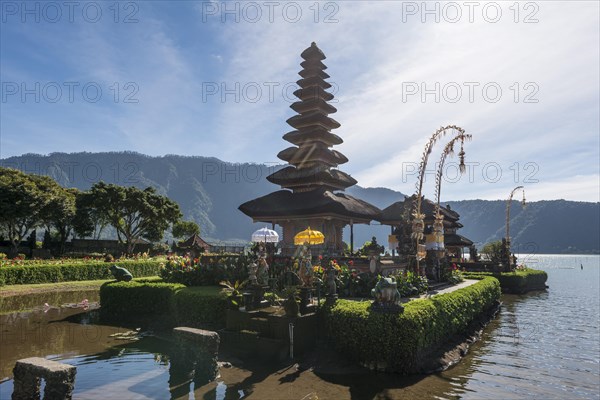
<box><xmin>0</xmin><ymin>151</ymin><xmax>600</xmax><ymax>254</ymax></box>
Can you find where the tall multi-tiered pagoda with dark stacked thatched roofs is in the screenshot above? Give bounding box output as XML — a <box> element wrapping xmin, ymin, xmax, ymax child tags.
<box><xmin>239</xmin><ymin>42</ymin><xmax>380</xmax><ymax>253</ymax></box>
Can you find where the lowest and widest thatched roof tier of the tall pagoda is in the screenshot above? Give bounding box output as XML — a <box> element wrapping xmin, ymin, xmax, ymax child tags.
<box><xmin>239</xmin><ymin>189</ymin><xmax>381</xmax><ymax>222</ymax></box>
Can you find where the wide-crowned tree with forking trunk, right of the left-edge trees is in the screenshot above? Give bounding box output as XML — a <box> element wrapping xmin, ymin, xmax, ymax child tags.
<box><xmin>89</xmin><ymin>182</ymin><xmax>181</xmax><ymax>254</ymax></box>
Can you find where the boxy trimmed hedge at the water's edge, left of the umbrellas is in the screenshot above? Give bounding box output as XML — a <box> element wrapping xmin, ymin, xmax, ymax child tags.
<box><xmin>100</xmin><ymin>279</ymin><xmax>228</xmax><ymax>327</ymax></box>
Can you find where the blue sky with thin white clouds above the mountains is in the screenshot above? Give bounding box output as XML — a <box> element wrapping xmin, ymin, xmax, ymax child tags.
<box><xmin>0</xmin><ymin>0</ymin><xmax>600</xmax><ymax>201</ymax></box>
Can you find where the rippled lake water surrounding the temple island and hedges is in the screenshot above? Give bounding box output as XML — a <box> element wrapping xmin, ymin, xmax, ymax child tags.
<box><xmin>0</xmin><ymin>255</ymin><xmax>600</xmax><ymax>399</ymax></box>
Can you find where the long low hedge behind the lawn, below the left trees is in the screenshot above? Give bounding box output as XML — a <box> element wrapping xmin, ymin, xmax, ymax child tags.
<box><xmin>0</xmin><ymin>260</ymin><xmax>161</xmax><ymax>285</ymax></box>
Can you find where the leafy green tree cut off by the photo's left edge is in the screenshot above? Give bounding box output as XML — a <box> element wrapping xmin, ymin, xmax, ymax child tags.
<box><xmin>0</xmin><ymin>167</ymin><xmax>52</xmax><ymax>257</ymax></box>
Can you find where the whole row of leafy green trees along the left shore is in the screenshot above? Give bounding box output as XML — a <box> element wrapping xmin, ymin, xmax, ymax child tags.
<box><xmin>0</xmin><ymin>168</ymin><xmax>188</xmax><ymax>258</ymax></box>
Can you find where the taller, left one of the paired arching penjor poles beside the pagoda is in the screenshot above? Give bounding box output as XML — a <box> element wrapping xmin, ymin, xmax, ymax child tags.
<box><xmin>411</xmin><ymin>125</ymin><xmax>465</xmax><ymax>275</ymax></box>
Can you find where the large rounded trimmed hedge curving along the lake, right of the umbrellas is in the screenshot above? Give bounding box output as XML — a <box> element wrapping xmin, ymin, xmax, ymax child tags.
<box><xmin>324</xmin><ymin>277</ymin><xmax>501</xmax><ymax>373</ymax></box>
